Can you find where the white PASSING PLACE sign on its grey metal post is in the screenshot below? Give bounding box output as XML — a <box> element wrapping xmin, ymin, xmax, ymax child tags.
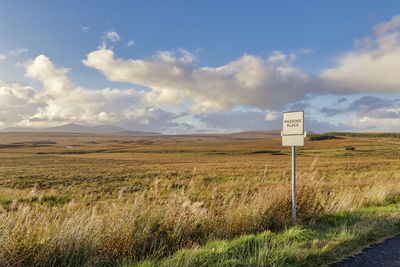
<box><xmin>281</xmin><ymin>110</ymin><xmax>306</xmax><ymax>224</ymax></box>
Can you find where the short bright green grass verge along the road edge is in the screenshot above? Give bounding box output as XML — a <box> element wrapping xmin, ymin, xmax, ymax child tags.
<box><xmin>133</xmin><ymin>204</ymin><xmax>400</xmax><ymax>266</ymax></box>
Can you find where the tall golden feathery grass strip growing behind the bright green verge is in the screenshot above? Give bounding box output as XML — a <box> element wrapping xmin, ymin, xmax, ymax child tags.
<box><xmin>0</xmin><ymin>176</ymin><xmax>400</xmax><ymax>266</ymax></box>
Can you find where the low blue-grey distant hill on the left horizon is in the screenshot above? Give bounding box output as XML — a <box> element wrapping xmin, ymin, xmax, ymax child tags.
<box><xmin>1</xmin><ymin>123</ymin><xmax>161</xmax><ymax>136</ymax></box>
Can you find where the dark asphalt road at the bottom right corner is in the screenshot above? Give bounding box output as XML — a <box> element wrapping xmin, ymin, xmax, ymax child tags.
<box><xmin>330</xmin><ymin>235</ymin><xmax>400</xmax><ymax>267</ymax></box>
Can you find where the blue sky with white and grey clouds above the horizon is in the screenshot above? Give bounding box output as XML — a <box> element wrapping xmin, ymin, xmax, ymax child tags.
<box><xmin>0</xmin><ymin>0</ymin><xmax>400</xmax><ymax>134</ymax></box>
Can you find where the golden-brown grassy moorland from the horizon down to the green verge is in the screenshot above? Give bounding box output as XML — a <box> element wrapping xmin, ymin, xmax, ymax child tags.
<box><xmin>0</xmin><ymin>133</ymin><xmax>400</xmax><ymax>266</ymax></box>
